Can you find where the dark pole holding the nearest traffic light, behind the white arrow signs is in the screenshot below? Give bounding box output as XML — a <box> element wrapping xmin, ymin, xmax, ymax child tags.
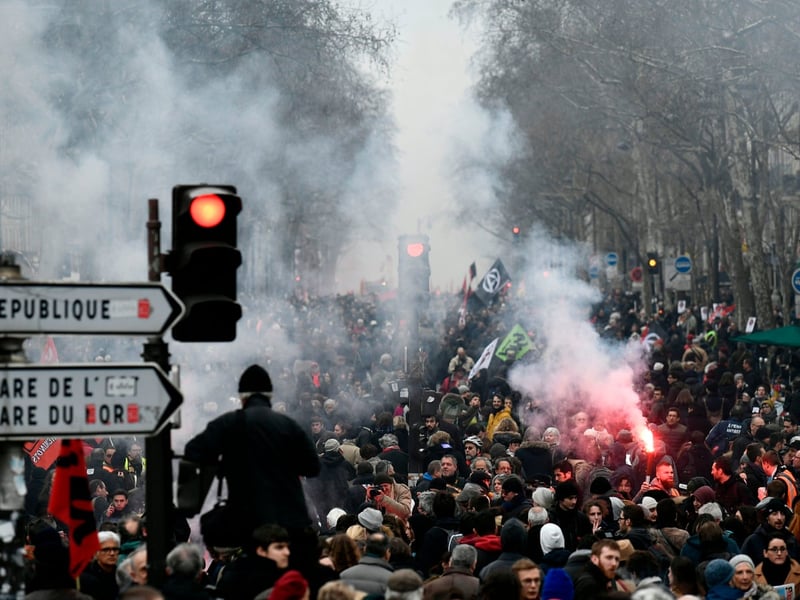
<box><xmin>142</xmin><ymin>198</ymin><xmax>174</xmax><ymax>587</ymax></box>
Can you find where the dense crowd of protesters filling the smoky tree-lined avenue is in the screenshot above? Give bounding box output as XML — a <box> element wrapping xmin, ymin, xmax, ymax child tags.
<box><xmin>14</xmin><ymin>294</ymin><xmax>800</xmax><ymax>600</ymax></box>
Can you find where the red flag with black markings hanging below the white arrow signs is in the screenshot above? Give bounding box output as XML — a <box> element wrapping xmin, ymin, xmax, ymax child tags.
<box><xmin>47</xmin><ymin>440</ymin><xmax>100</xmax><ymax>578</ymax></box>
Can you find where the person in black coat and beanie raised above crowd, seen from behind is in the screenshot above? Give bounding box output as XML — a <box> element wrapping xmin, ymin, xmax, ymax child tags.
<box><xmin>184</xmin><ymin>365</ymin><xmax>321</xmax><ymax>571</ymax></box>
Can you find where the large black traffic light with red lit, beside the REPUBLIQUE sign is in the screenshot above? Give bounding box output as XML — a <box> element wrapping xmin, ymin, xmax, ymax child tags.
<box><xmin>167</xmin><ymin>184</ymin><xmax>242</xmax><ymax>342</ymax></box>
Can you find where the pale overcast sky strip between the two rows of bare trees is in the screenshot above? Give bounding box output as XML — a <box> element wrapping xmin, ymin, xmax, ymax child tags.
<box><xmin>341</xmin><ymin>0</ymin><xmax>506</xmax><ymax>291</ymax></box>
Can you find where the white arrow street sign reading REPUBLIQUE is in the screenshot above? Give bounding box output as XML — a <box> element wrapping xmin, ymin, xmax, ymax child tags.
<box><xmin>0</xmin><ymin>281</ymin><xmax>183</xmax><ymax>335</ymax></box>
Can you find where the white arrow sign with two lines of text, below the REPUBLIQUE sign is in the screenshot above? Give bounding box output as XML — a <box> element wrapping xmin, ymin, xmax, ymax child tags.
<box><xmin>0</xmin><ymin>363</ymin><xmax>183</xmax><ymax>439</ymax></box>
